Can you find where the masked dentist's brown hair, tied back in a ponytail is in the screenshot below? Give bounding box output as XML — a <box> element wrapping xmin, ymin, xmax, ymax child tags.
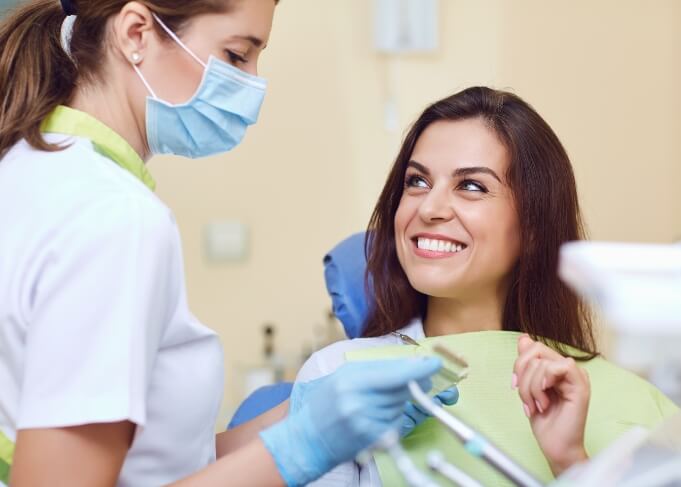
<box><xmin>0</xmin><ymin>0</ymin><xmax>276</xmax><ymax>158</ymax></box>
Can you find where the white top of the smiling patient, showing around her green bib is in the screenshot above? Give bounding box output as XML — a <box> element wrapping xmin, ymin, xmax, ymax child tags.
<box><xmin>296</xmin><ymin>319</ymin><xmax>426</xmax><ymax>487</ymax></box>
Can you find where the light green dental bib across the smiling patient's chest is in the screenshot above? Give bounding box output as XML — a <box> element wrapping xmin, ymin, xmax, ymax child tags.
<box><xmin>346</xmin><ymin>331</ymin><xmax>679</xmax><ymax>487</ymax></box>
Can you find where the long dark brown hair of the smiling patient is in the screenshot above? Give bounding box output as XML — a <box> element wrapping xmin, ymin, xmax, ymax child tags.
<box><xmin>364</xmin><ymin>87</ymin><xmax>597</xmax><ymax>358</ymax></box>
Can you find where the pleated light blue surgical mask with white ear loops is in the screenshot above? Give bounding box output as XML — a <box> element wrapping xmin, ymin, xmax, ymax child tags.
<box><xmin>133</xmin><ymin>15</ymin><xmax>267</xmax><ymax>158</ymax></box>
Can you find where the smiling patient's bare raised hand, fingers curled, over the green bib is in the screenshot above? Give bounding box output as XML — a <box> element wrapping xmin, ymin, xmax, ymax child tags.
<box><xmin>512</xmin><ymin>335</ymin><xmax>591</xmax><ymax>476</ymax></box>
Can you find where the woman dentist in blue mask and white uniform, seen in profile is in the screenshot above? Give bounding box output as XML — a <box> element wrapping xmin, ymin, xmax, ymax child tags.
<box><xmin>0</xmin><ymin>0</ymin><xmax>440</xmax><ymax>487</ymax></box>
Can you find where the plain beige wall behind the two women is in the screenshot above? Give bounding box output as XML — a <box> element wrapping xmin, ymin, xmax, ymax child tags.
<box><xmin>151</xmin><ymin>0</ymin><xmax>681</xmax><ymax>426</ymax></box>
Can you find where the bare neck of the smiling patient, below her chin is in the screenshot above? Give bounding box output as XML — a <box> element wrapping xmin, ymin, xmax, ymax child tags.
<box><xmin>423</xmin><ymin>294</ymin><xmax>505</xmax><ymax>336</ymax></box>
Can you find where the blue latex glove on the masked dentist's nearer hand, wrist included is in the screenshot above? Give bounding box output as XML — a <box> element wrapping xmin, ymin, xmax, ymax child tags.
<box><xmin>260</xmin><ymin>358</ymin><xmax>442</xmax><ymax>486</ymax></box>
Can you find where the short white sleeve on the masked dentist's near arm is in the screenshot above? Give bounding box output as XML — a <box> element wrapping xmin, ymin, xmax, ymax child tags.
<box><xmin>17</xmin><ymin>195</ymin><xmax>182</xmax><ymax>429</ymax></box>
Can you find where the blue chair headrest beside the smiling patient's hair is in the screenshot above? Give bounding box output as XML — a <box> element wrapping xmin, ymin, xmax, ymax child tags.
<box><xmin>324</xmin><ymin>232</ymin><xmax>369</xmax><ymax>338</ymax></box>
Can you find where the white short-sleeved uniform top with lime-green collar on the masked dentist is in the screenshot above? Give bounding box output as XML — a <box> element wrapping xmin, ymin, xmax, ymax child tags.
<box><xmin>0</xmin><ymin>107</ymin><xmax>224</xmax><ymax>487</ymax></box>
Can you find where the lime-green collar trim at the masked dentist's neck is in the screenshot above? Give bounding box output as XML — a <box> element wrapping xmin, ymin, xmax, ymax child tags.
<box><xmin>40</xmin><ymin>105</ymin><xmax>156</xmax><ymax>191</ymax></box>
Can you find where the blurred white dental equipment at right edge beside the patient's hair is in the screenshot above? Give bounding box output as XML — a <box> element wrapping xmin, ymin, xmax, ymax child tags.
<box><xmin>558</xmin><ymin>242</ymin><xmax>681</xmax><ymax>405</ymax></box>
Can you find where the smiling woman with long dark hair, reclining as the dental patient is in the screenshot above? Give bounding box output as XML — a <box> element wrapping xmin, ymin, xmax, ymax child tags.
<box><xmin>298</xmin><ymin>87</ymin><xmax>676</xmax><ymax>486</ymax></box>
